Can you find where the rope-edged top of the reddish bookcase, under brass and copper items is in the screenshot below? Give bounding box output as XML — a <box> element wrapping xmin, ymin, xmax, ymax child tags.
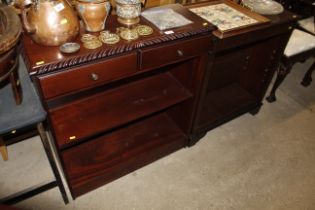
<box><xmin>22</xmin><ymin>4</ymin><xmax>215</xmax><ymax>75</ymax></box>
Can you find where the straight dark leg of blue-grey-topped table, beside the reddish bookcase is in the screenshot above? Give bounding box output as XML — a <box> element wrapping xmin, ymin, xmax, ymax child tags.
<box><xmin>37</xmin><ymin>123</ymin><xmax>69</xmax><ymax>204</ymax></box>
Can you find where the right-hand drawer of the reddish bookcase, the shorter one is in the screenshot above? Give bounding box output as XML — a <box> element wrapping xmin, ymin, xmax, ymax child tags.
<box><xmin>140</xmin><ymin>36</ymin><xmax>212</xmax><ymax>70</ymax></box>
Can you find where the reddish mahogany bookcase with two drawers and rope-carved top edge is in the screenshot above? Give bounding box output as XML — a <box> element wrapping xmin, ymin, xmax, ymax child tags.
<box><xmin>23</xmin><ymin>5</ymin><xmax>214</xmax><ymax>198</ymax></box>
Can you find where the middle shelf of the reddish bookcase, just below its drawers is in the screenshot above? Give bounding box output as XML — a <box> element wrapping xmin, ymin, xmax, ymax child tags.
<box><xmin>49</xmin><ymin>73</ymin><xmax>191</xmax><ymax>147</ymax></box>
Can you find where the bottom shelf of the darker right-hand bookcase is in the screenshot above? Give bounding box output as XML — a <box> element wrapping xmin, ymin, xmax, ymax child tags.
<box><xmin>195</xmin><ymin>83</ymin><xmax>259</xmax><ymax>129</ymax></box>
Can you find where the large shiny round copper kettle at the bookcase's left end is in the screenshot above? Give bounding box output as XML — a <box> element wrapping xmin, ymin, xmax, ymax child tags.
<box><xmin>20</xmin><ymin>0</ymin><xmax>79</xmax><ymax>46</ymax></box>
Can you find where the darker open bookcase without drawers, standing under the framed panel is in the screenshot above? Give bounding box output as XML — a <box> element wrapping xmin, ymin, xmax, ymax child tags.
<box><xmin>192</xmin><ymin>8</ymin><xmax>294</xmax><ymax>144</ymax></box>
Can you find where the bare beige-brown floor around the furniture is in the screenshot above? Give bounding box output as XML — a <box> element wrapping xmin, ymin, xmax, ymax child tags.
<box><xmin>0</xmin><ymin>60</ymin><xmax>315</xmax><ymax>210</ymax></box>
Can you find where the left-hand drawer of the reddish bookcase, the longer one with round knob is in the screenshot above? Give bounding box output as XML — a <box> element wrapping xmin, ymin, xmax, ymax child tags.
<box><xmin>39</xmin><ymin>53</ymin><xmax>137</xmax><ymax>99</ymax></box>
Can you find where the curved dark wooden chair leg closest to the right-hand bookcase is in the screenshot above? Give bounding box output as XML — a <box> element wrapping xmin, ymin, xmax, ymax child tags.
<box><xmin>266</xmin><ymin>64</ymin><xmax>292</xmax><ymax>103</ymax></box>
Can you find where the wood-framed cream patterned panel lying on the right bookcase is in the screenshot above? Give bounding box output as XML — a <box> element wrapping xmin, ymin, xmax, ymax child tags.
<box><xmin>189</xmin><ymin>0</ymin><xmax>270</xmax><ymax>38</ymax></box>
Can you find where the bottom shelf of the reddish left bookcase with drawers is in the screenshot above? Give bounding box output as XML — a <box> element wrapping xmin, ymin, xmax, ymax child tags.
<box><xmin>62</xmin><ymin>113</ymin><xmax>187</xmax><ymax>198</ymax></box>
